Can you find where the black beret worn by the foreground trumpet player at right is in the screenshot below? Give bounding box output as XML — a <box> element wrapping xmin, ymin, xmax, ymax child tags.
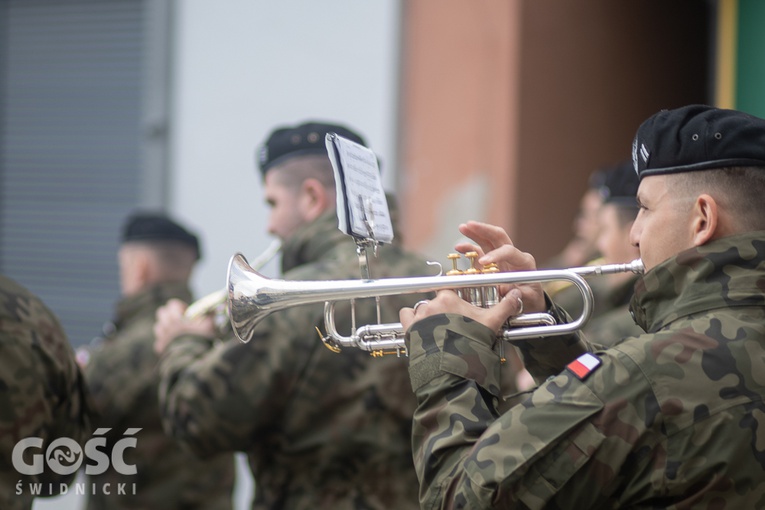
<box><xmin>632</xmin><ymin>105</ymin><xmax>765</xmax><ymax>179</ymax></box>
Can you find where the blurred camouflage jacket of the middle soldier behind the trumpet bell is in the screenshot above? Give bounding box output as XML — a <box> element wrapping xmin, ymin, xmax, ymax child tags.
<box><xmin>160</xmin><ymin>214</ymin><xmax>433</xmax><ymax>510</ymax></box>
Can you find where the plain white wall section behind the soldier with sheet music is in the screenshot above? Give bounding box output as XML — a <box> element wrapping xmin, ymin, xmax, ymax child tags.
<box><xmin>170</xmin><ymin>0</ymin><xmax>400</xmax><ymax>296</ymax></box>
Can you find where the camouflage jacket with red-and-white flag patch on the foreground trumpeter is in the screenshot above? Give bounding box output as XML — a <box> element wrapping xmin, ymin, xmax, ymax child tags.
<box><xmin>410</xmin><ymin>232</ymin><xmax>765</xmax><ymax>509</ymax></box>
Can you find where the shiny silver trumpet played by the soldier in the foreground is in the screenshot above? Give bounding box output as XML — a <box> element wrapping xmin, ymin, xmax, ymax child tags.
<box><xmin>228</xmin><ymin>253</ymin><xmax>644</xmax><ymax>356</ymax></box>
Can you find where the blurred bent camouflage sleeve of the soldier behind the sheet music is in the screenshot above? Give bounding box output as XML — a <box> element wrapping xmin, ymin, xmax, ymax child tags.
<box><xmin>159</xmin><ymin>307</ymin><xmax>318</xmax><ymax>457</ymax></box>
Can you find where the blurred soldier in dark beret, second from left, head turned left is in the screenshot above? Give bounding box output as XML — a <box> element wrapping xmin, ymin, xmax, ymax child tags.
<box><xmin>85</xmin><ymin>212</ymin><xmax>234</xmax><ymax>510</ymax></box>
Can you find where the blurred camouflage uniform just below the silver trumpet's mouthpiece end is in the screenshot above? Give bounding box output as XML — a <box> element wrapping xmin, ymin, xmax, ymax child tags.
<box><xmin>580</xmin><ymin>275</ymin><xmax>644</xmax><ymax>347</ymax></box>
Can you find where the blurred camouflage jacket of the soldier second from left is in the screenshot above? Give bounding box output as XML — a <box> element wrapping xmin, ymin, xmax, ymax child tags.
<box><xmin>85</xmin><ymin>283</ymin><xmax>234</xmax><ymax>510</ymax></box>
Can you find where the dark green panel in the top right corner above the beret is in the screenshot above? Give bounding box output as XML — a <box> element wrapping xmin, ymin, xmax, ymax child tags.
<box><xmin>736</xmin><ymin>0</ymin><xmax>765</xmax><ymax>117</ymax></box>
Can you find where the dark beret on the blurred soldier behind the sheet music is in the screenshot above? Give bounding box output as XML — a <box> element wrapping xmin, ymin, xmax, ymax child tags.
<box><xmin>257</xmin><ymin>121</ymin><xmax>366</xmax><ymax>177</ymax></box>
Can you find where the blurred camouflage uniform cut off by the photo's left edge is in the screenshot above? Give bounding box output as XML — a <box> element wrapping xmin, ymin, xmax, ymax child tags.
<box><xmin>0</xmin><ymin>276</ymin><xmax>91</xmax><ymax>510</ymax></box>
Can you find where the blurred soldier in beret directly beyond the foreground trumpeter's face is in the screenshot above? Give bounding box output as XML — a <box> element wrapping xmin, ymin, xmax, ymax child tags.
<box><xmin>580</xmin><ymin>160</ymin><xmax>643</xmax><ymax>347</ymax></box>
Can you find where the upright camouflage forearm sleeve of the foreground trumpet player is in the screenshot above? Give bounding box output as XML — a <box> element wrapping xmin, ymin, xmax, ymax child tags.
<box><xmin>407</xmin><ymin>314</ymin><xmax>508</xmax><ymax>508</ymax></box>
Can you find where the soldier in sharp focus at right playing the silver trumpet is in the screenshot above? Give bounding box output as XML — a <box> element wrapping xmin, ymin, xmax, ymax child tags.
<box><xmin>401</xmin><ymin>105</ymin><xmax>765</xmax><ymax>509</ymax></box>
